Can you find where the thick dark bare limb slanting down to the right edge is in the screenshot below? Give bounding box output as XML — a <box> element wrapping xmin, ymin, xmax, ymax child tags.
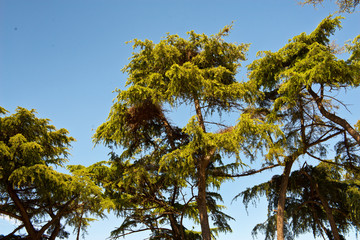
<box><xmin>308</xmin><ymin>87</ymin><xmax>360</xmax><ymax>145</ymax></box>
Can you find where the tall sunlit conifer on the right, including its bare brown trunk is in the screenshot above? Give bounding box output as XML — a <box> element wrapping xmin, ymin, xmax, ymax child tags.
<box><xmin>249</xmin><ymin>17</ymin><xmax>360</xmax><ymax>240</ymax></box>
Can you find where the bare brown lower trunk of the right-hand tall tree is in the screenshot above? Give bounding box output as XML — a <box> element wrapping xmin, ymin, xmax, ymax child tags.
<box><xmin>276</xmin><ymin>159</ymin><xmax>294</xmax><ymax>240</ymax></box>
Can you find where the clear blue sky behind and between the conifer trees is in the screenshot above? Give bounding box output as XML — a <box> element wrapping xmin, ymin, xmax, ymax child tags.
<box><xmin>0</xmin><ymin>0</ymin><xmax>360</xmax><ymax>240</ymax></box>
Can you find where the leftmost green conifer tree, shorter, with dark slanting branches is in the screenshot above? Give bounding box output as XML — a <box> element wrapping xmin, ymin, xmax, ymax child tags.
<box><xmin>0</xmin><ymin>107</ymin><xmax>103</xmax><ymax>240</ymax></box>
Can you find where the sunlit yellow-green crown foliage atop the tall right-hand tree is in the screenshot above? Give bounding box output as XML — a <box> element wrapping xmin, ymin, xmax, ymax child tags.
<box><xmin>249</xmin><ymin>17</ymin><xmax>360</xmax><ymax>118</ymax></box>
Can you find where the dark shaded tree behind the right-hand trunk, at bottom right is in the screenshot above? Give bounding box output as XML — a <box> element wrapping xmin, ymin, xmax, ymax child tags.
<box><xmin>239</xmin><ymin>163</ymin><xmax>360</xmax><ymax>239</ymax></box>
